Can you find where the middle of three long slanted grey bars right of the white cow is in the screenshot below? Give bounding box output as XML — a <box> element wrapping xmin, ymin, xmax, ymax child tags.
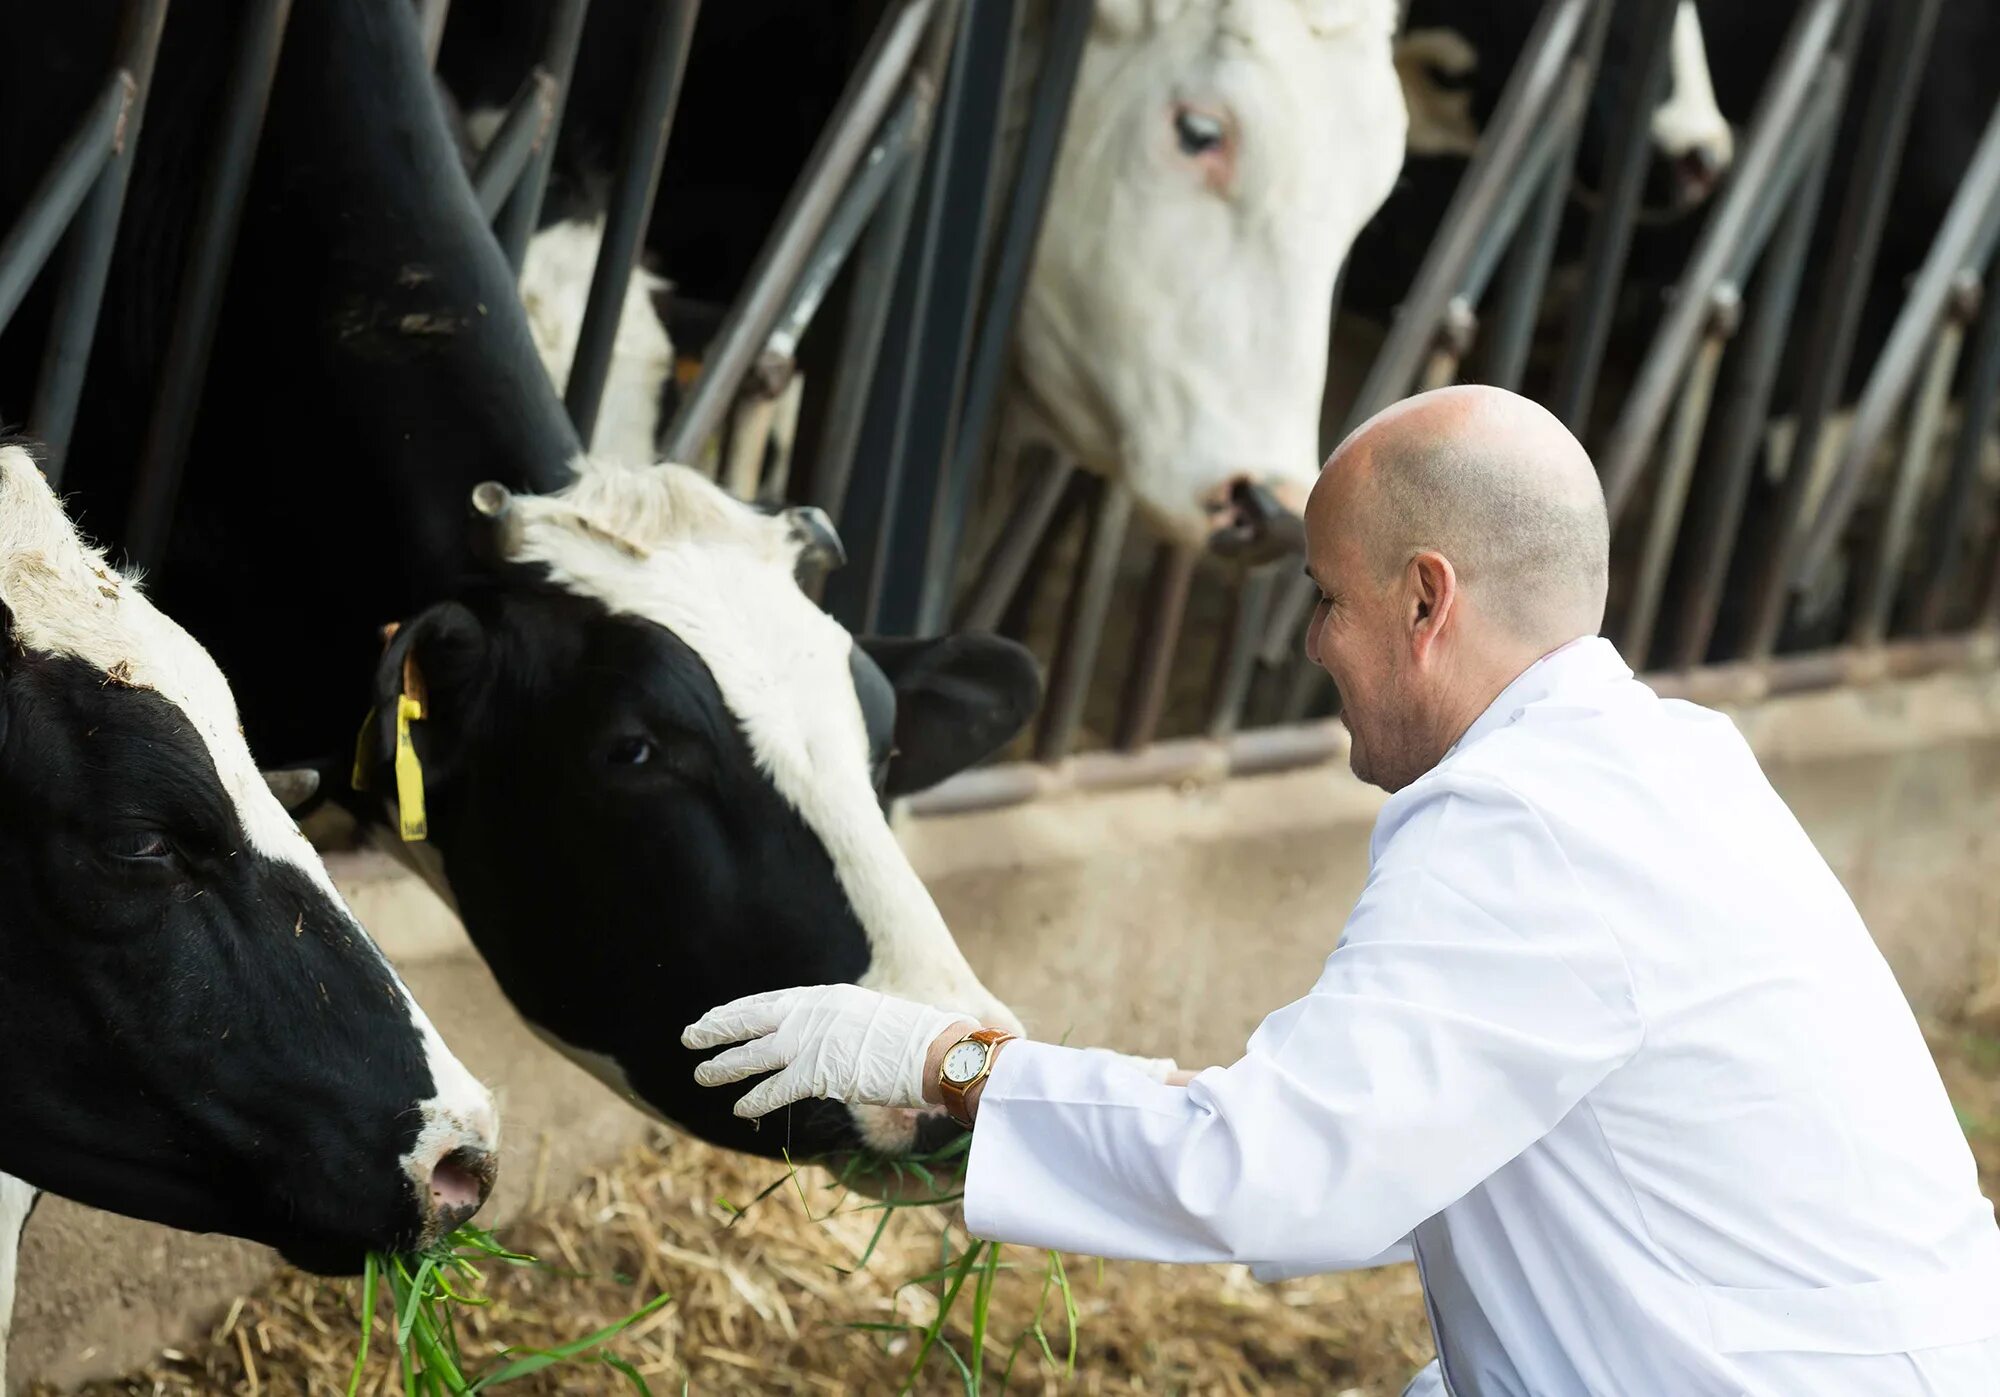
<box><xmin>1598</xmin><ymin>0</ymin><xmax>1846</xmax><ymax>528</ymax></box>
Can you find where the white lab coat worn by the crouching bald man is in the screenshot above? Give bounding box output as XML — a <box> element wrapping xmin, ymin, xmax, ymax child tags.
<box><xmin>964</xmin><ymin>636</ymin><xmax>2000</xmax><ymax>1397</ymax></box>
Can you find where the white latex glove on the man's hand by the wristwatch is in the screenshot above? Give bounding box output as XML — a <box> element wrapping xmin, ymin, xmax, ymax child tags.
<box><xmin>680</xmin><ymin>985</ymin><xmax>978</xmax><ymax>1121</ymax></box>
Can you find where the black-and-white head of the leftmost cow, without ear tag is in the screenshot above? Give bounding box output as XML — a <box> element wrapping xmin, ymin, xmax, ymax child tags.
<box><xmin>0</xmin><ymin>446</ymin><xmax>496</xmax><ymax>1271</ymax></box>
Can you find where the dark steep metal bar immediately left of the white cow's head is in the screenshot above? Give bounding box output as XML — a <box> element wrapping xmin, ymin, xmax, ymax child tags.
<box><xmin>918</xmin><ymin>2</ymin><xmax>1094</xmax><ymax>630</ymax></box>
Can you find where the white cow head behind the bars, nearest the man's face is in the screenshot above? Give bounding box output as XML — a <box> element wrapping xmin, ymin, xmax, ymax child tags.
<box><xmin>1018</xmin><ymin>0</ymin><xmax>1404</xmax><ymax>544</ymax></box>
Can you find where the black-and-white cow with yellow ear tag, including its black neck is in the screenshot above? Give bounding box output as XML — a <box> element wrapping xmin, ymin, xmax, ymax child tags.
<box><xmin>0</xmin><ymin>0</ymin><xmax>1040</xmax><ymax>1155</ymax></box>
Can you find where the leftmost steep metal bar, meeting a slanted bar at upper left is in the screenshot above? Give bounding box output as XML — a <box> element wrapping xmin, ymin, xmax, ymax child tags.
<box><xmin>28</xmin><ymin>0</ymin><xmax>166</xmax><ymax>484</ymax></box>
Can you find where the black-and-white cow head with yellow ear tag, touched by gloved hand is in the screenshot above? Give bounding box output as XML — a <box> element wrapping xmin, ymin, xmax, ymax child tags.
<box><xmin>368</xmin><ymin>460</ymin><xmax>1040</xmax><ymax>1157</ymax></box>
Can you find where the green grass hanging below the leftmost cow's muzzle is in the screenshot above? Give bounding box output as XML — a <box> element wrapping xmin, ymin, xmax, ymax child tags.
<box><xmin>348</xmin><ymin>1227</ymin><xmax>668</xmax><ymax>1397</ymax></box>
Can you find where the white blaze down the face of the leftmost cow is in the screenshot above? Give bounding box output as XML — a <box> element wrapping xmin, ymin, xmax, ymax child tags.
<box><xmin>0</xmin><ymin>446</ymin><xmax>494</xmax><ymax>1137</ymax></box>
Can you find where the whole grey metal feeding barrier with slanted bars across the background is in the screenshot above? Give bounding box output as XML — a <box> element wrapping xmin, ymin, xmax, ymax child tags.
<box><xmin>15</xmin><ymin>0</ymin><xmax>2000</xmax><ymax>811</ymax></box>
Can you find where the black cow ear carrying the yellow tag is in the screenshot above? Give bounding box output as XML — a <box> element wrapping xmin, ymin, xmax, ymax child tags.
<box><xmin>374</xmin><ymin>602</ymin><xmax>488</xmax><ymax>783</ymax></box>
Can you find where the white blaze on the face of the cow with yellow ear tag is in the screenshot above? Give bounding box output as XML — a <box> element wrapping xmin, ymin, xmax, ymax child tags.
<box><xmin>500</xmin><ymin>458</ymin><xmax>1014</xmax><ymax>1080</ymax></box>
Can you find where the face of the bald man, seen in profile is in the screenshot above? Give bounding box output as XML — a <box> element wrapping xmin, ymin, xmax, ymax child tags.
<box><xmin>1306</xmin><ymin>462</ymin><xmax>1432</xmax><ymax>791</ymax></box>
